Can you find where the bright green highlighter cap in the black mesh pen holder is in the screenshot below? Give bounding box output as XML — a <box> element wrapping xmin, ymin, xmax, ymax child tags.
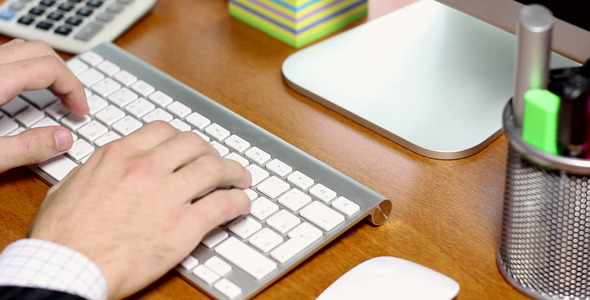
<box><xmin>522</xmin><ymin>89</ymin><xmax>560</xmax><ymax>154</ymax></box>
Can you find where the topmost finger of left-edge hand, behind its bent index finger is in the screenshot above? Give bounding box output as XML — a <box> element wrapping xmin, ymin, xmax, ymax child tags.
<box><xmin>0</xmin><ymin>39</ymin><xmax>63</xmax><ymax>64</ymax></box>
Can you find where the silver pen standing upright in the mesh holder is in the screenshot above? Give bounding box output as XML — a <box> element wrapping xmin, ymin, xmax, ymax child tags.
<box><xmin>512</xmin><ymin>4</ymin><xmax>554</xmax><ymax>125</ymax></box>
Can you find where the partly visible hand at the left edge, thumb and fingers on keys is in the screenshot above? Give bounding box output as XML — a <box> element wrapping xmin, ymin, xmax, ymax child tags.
<box><xmin>0</xmin><ymin>40</ymin><xmax>88</xmax><ymax>172</ymax></box>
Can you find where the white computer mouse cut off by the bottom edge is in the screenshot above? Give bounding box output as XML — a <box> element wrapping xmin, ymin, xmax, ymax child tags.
<box><xmin>317</xmin><ymin>256</ymin><xmax>459</xmax><ymax>300</ymax></box>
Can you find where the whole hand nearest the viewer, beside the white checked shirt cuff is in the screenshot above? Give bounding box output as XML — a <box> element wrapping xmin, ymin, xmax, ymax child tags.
<box><xmin>30</xmin><ymin>122</ymin><xmax>252</xmax><ymax>299</ymax></box>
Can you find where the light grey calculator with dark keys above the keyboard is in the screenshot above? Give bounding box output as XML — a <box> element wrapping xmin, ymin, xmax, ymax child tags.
<box><xmin>0</xmin><ymin>0</ymin><xmax>157</xmax><ymax>53</ymax></box>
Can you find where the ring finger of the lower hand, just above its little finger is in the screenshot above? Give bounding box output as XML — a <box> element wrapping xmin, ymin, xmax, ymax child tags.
<box><xmin>170</xmin><ymin>155</ymin><xmax>252</xmax><ymax>199</ymax></box>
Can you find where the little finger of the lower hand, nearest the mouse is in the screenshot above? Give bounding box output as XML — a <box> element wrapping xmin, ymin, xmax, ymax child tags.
<box><xmin>189</xmin><ymin>189</ymin><xmax>252</xmax><ymax>233</ymax></box>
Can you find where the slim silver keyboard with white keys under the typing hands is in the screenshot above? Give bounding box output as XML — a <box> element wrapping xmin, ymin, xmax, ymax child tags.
<box><xmin>0</xmin><ymin>43</ymin><xmax>391</xmax><ymax>299</ymax></box>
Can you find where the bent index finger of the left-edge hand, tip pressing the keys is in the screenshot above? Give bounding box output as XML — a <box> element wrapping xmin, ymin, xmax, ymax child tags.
<box><xmin>0</xmin><ymin>55</ymin><xmax>89</xmax><ymax>115</ymax></box>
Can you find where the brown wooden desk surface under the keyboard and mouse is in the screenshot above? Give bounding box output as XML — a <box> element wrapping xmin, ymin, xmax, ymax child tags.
<box><xmin>0</xmin><ymin>0</ymin><xmax>526</xmax><ymax>300</ymax></box>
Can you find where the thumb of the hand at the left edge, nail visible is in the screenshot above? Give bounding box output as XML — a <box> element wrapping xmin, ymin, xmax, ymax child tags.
<box><xmin>0</xmin><ymin>126</ymin><xmax>73</xmax><ymax>173</ymax></box>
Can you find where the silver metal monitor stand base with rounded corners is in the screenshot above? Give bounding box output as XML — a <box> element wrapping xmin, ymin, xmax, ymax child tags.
<box><xmin>282</xmin><ymin>0</ymin><xmax>579</xmax><ymax>159</ymax></box>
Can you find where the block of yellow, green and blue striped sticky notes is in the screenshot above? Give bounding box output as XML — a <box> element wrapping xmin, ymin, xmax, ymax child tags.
<box><xmin>229</xmin><ymin>0</ymin><xmax>368</xmax><ymax>47</ymax></box>
